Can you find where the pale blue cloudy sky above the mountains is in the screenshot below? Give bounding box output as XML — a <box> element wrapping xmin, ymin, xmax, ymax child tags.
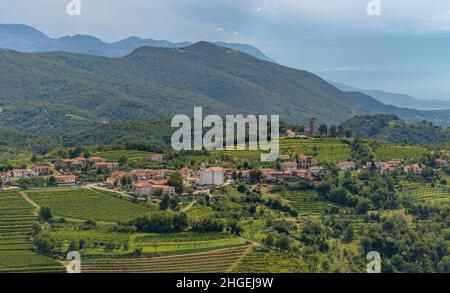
<box><xmin>0</xmin><ymin>0</ymin><xmax>450</xmax><ymax>99</ymax></box>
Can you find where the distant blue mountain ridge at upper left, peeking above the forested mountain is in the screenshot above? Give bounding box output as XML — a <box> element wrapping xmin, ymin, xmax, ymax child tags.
<box><xmin>0</xmin><ymin>24</ymin><xmax>274</xmax><ymax>62</ymax></box>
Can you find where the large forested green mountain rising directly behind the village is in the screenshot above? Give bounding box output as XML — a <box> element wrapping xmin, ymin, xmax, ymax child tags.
<box><xmin>0</xmin><ymin>24</ymin><xmax>450</xmax><ymax>151</ymax></box>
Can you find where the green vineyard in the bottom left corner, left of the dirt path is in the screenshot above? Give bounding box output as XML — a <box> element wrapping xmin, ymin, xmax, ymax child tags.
<box><xmin>0</xmin><ymin>191</ymin><xmax>63</xmax><ymax>272</ymax></box>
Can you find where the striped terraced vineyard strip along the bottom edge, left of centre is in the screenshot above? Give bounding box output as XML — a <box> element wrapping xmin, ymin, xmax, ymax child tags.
<box><xmin>81</xmin><ymin>246</ymin><xmax>248</xmax><ymax>273</ymax></box>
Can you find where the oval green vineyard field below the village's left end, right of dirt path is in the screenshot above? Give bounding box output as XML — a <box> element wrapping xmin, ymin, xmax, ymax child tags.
<box><xmin>26</xmin><ymin>188</ymin><xmax>155</xmax><ymax>222</ymax></box>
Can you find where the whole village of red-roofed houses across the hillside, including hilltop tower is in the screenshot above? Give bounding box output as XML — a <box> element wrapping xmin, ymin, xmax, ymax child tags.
<box><xmin>0</xmin><ymin>118</ymin><xmax>440</xmax><ymax>200</ymax></box>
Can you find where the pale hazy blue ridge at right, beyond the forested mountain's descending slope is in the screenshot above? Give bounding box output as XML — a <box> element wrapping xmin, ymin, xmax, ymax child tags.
<box><xmin>330</xmin><ymin>82</ymin><xmax>450</xmax><ymax>110</ymax></box>
